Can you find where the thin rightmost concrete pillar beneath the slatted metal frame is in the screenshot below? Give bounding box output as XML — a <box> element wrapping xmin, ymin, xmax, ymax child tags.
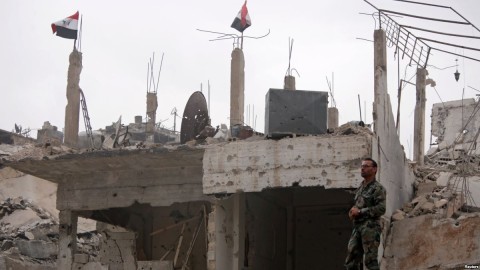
<box><xmin>413</xmin><ymin>68</ymin><xmax>427</xmax><ymax>166</ymax></box>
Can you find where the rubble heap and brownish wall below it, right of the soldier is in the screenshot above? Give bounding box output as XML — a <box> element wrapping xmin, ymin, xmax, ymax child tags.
<box><xmin>382</xmin><ymin>143</ymin><xmax>480</xmax><ymax>269</ymax></box>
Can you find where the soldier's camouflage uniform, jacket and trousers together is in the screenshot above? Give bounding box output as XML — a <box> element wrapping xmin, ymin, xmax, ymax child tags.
<box><xmin>345</xmin><ymin>179</ymin><xmax>386</xmax><ymax>270</ymax></box>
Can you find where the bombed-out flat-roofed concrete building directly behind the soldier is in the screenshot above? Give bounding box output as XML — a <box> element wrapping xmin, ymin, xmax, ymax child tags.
<box><xmin>0</xmin><ymin>30</ymin><xmax>414</xmax><ymax>269</ymax></box>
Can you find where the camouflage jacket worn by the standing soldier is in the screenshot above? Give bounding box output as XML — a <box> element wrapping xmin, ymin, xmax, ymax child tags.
<box><xmin>354</xmin><ymin>180</ymin><xmax>386</xmax><ymax>224</ymax></box>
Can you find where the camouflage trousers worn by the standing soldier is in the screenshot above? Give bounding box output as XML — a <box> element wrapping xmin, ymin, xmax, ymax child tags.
<box><xmin>345</xmin><ymin>220</ymin><xmax>381</xmax><ymax>270</ymax></box>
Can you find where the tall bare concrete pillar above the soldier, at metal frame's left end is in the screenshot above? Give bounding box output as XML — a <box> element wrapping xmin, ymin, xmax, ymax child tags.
<box><xmin>373</xmin><ymin>29</ymin><xmax>389</xmax><ymax>134</ymax></box>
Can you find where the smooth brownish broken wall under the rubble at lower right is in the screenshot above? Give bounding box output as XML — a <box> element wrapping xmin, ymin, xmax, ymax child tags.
<box><xmin>382</xmin><ymin>213</ymin><xmax>480</xmax><ymax>269</ymax></box>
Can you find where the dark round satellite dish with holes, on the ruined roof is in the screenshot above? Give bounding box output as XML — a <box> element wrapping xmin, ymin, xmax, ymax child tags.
<box><xmin>180</xmin><ymin>91</ymin><xmax>210</xmax><ymax>144</ymax></box>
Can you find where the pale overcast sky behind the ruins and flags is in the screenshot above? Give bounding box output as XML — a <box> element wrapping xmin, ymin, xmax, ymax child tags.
<box><xmin>0</xmin><ymin>0</ymin><xmax>480</xmax><ymax>156</ymax></box>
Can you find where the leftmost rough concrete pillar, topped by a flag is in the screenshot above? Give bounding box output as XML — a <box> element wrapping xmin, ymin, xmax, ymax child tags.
<box><xmin>65</xmin><ymin>48</ymin><xmax>82</xmax><ymax>147</ymax></box>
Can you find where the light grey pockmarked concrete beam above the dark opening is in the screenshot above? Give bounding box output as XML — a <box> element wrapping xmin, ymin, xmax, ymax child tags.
<box><xmin>203</xmin><ymin>134</ymin><xmax>372</xmax><ymax>194</ymax></box>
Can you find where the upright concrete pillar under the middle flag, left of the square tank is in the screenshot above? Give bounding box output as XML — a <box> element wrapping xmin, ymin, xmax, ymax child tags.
<box><xmin>230</xmin><ymin>48</ymin><xmax>245</xmax><ymax>127</ymax></box>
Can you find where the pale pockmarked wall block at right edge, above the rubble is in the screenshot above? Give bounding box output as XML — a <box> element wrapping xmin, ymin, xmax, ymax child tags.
<box><xmin>431</xmin><ymin>98</ymin><xmax>480</xmax><ymax>146</ymax></box>
